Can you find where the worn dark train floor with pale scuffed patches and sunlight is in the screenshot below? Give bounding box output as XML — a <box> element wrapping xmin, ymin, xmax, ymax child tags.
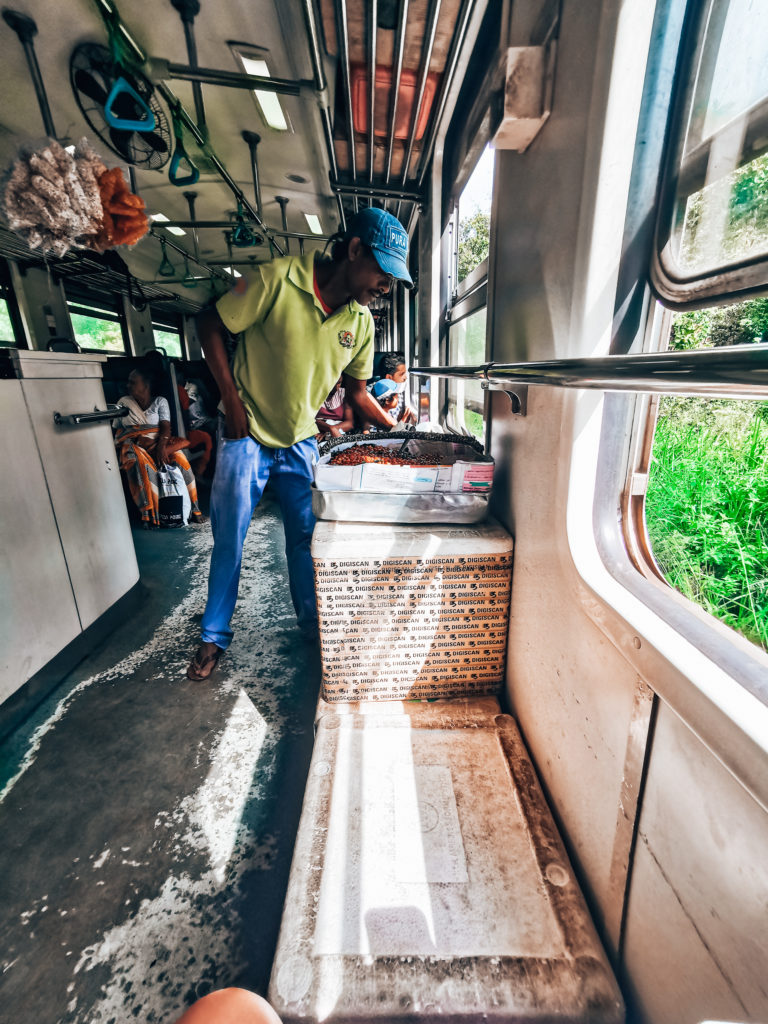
<box><xmin>0</xmin><ymin>489</ymin><xmax>319</xmax><ymax>1024</ymax></box>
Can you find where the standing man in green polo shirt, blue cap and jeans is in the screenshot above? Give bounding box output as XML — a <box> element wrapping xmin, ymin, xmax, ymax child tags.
<box><xmin>187</xmin><ymin>207</ymin><xmax>413</xmax><ymax>679</ymax></box>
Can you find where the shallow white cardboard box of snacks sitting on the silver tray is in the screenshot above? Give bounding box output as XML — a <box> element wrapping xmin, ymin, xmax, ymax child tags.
<box><xmin>314</xmin><ymin>434</ymin><xmax>494</xmax><ymax>494</ymax></box>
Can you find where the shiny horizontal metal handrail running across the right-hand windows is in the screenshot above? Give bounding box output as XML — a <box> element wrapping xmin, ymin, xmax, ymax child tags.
<box><xmin>411</xmin><ymin>344</ymin><xmax>768</xmax><ymax>400</ymax></box>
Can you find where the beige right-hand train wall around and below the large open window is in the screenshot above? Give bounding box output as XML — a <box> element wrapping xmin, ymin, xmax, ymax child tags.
<box><xmin>450</xmin><ymin>3</ymin><xmax>768</xmax><ymax>1024</ymax></box>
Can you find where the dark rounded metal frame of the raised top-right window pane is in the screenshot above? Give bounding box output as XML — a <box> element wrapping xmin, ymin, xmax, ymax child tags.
<box><xmin>649</xmin><ymin>0</ymin><xmax>768</xmax><ymax>311</ymax></box>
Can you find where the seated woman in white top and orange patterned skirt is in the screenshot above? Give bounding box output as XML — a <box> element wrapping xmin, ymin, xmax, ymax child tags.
<box><xmin>115</xmin><ymin>370</ymin><xmax>205</xmax><ymax>529</ymax></box>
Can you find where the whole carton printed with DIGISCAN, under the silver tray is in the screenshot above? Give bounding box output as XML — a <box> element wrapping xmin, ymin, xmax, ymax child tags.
<box><xmin>312</xmin><ymin>522</ymin><xmax>512</xmax><ymax>702</ymax></box>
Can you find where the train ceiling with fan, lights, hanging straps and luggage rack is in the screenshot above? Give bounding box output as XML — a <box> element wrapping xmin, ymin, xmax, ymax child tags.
<box><xmin>0</xmin><ymin>0</ymin><xmax>475</xmax><ymax>303</ymax></box>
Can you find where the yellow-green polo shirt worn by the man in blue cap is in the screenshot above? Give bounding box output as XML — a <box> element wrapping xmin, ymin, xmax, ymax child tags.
<box><xmin>216</xmin><ymin>252</ymin><xmax>374</xmax><ymax>447</ymax></box>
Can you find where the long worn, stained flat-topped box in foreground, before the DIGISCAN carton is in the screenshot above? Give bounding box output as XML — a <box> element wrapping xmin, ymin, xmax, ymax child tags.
<box><xmin>269</xmin><ymin>698</ymin><xmax>625</xmax><ymax>1024</ymax></box>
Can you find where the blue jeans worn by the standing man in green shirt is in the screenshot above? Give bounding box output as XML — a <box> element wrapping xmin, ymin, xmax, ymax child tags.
<box><xmin>202</xmin><ymin>437</ymin><xmax>317</xmax><ymax>648</ymax></box>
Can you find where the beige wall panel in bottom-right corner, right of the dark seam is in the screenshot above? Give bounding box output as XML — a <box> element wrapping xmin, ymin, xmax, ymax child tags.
<box><xmin>625</xmin><ymin>703</ymin><xmax>768</xmax><ymax>1024</ymax></box>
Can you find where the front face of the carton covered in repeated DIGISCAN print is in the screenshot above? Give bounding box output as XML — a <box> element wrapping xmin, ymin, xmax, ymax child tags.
<box><xmin>314</xmin><ymin>554</ymin><xmax>512</xmax><ymax>700</ymax></box>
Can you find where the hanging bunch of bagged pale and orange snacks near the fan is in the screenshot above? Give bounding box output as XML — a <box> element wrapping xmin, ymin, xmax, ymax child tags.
<box><xmin>3</xmin><ymin>138</ymin><xmax>150</xmax><ymax>256</ymax></box>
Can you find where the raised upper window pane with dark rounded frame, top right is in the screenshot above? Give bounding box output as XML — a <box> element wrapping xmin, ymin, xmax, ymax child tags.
<box><xmin>653</xmin><ymin>0</ymin><xmax>768</xmax><ymax>306</ymax></box>
